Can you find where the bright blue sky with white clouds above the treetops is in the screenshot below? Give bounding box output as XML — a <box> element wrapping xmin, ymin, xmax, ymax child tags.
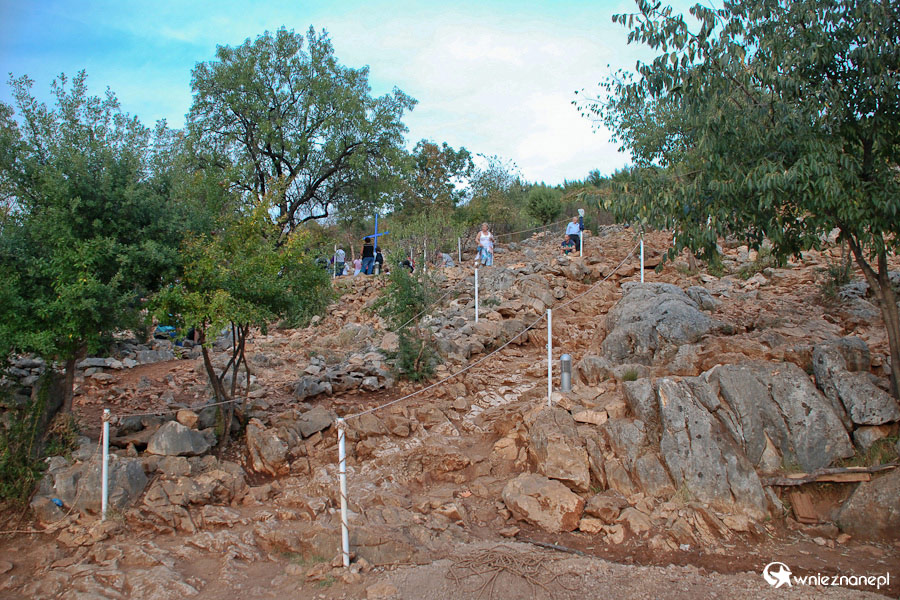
<box><xmin>0</xmin><ymin>0</ymin><xmax>686</xmax><ymax>184</ymax></box>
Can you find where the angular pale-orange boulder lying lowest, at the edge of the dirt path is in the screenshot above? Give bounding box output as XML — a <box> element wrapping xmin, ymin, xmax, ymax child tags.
<box><xmin>503</xmin><ymin>473</ymin><xmax>584</xmax><ymax>533</ymax></box>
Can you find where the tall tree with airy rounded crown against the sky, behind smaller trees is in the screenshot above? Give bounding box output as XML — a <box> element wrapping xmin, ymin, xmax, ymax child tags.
<box><xmin>189</xmin><ymin>27</ymin><xmax>415</xmax><ymax>231</ymax></box>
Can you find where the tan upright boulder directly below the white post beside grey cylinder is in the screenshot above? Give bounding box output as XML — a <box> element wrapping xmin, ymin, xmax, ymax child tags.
<box><xmin>528</xmin><ymin>406</ymin><xmax>591</xmax><ymax>492</ymax></box>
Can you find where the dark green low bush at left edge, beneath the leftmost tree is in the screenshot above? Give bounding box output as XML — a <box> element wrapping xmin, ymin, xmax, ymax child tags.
<box><xmin>0</xmin><ymin>372</ymin><xmax>77</xmax><ymax>506</ymax></box>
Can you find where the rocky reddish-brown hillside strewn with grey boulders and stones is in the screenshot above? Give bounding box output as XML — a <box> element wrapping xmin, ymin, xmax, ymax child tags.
<box><xmin>0</xmin><ymin>227</ymin><xmax>900</xmax><ymax>598</ymax></box>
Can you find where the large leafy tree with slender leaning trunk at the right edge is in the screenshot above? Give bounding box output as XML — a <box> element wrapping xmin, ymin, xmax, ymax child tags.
<box><xmin>581</xmin><ymin>0</ymin><xmax>900</xmax><ymax>396</ymax></box>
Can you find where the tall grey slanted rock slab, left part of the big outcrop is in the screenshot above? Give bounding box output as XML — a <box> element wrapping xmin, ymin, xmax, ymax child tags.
<box><xmin>658</xmin><ymin>378</ymin><xmax>767</xmax><ymax>519</ymax></box>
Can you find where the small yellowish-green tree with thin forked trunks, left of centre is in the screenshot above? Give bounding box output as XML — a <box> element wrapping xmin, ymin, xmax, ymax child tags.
<box><xmin>153</xmin><ymin>194</ymin><xmax>331</xmax><ymax>448</ymax></box>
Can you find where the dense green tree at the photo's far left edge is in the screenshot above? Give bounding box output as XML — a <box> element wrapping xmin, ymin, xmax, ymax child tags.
<box><xmin>0</xmin><ymin>71</ymin><xmax>184</xmax><ymax>411</ymax></box>
